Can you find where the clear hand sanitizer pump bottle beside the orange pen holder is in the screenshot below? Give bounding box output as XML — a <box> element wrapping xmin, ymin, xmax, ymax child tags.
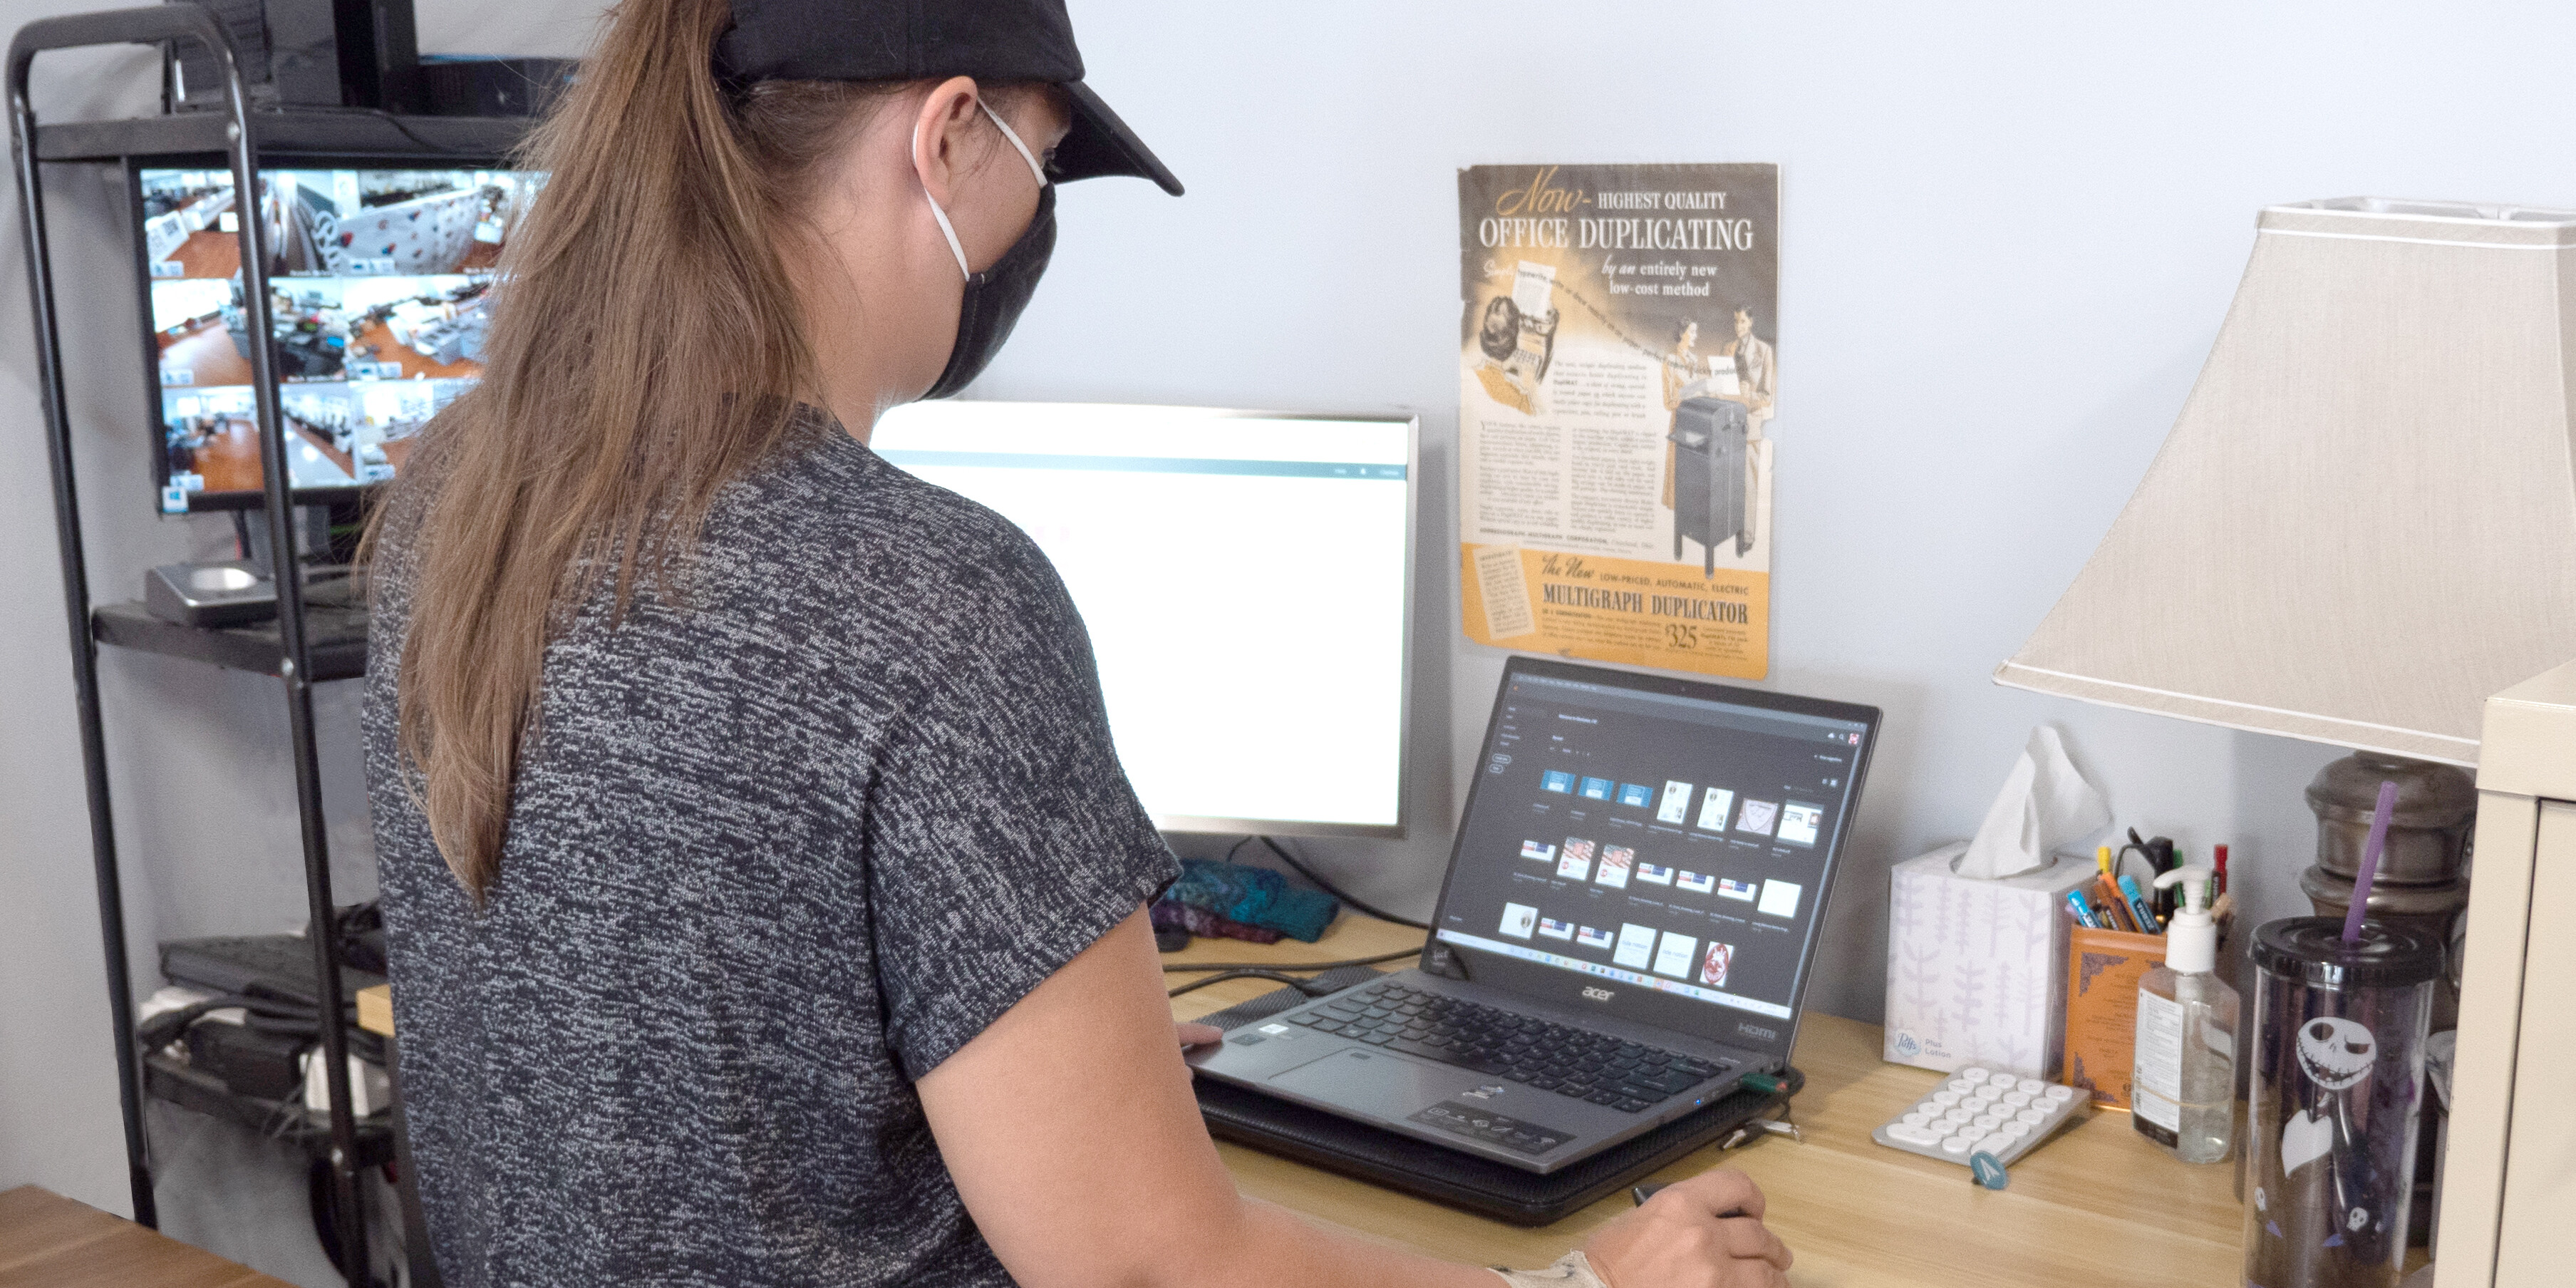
<box><xmin>2131</xmin><ymin>863</ymin><xmax>2236</xmax><ymax>1162</ymax></box>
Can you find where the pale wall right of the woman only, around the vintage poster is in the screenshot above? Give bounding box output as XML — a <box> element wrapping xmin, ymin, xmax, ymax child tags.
<box><xmin>979</xmin><ymin>3</ymin><xmax>2576</xmax><ymax>1018</ymax></box>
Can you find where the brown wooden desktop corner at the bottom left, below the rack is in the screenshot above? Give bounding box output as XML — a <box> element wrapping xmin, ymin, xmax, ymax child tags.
<box><xmin>0</xmin><ymin>1185</ymin><xmax>291</xmax><ymax>1288</ymax></box>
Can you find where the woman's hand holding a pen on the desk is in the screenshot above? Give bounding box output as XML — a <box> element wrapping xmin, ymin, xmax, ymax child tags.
<box><xmin>1584</xmin><ymin>1167</ymin><xmax>1793</xmax><ymax>1288</ymax></box>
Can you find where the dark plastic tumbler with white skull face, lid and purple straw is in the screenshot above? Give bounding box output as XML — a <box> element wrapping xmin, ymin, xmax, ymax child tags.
<box><xmin>2246</xmin><ymin>917</ymin><xmax>2442</xmax><ymax>1288</ymax></box>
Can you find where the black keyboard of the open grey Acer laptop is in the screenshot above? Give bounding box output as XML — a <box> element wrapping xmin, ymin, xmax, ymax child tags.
<box><xmin>1288</xmin><ymin>984</ymin><xmax>1734</xmax><ymax>1113</ymax></box>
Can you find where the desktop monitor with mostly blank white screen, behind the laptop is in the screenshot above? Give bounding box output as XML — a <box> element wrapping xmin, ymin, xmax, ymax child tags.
<box><xmin>871</xmin><ymin>402</ymin><xmax>1417</xmax><ymax>838</ymax></box>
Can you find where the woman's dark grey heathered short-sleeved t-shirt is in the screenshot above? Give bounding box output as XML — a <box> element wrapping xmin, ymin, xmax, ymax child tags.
<box><xmin>366</xmin><ymin>417</ymin><xmax>1174</xmax><ymax>1288</ymax></box>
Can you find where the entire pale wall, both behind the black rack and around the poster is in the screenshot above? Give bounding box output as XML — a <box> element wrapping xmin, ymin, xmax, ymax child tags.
<box><xmin>0</xmin><ymin>0</ymin><xmax>2576</xmax><ymax>1252</ymax></box>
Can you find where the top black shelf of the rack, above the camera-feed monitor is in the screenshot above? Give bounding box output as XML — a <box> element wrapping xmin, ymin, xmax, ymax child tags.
<box><xmin>36</xmin><ymin>108</ymin><xmax>533</xmax><ymax>165</ymax></box>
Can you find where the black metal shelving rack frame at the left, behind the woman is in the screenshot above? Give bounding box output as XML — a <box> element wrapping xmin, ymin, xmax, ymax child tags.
<box><xmin>8</xmin><ymin>5</ymin><xmax>528</xmax><ymax>1283</ymax></box>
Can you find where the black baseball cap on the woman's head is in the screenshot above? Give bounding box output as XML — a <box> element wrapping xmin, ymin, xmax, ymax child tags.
<box><xmin>716</xmin><ymin>0</ymin><xmax>1180</xmax><ymax>196</ymax></box>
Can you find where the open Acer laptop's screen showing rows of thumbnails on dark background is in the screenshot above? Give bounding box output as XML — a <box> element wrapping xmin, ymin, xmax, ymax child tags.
<box><xmin>1432</xmin><ymin>659</ymin><xmax>1878</xmax><ymax>1053</ymax></box>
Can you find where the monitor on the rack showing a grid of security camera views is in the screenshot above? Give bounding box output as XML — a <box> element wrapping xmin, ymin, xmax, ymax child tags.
<box><xmin>131</xmin><ymin>168</ymin><xmax>541</xmax><ymax>515</ymax></box>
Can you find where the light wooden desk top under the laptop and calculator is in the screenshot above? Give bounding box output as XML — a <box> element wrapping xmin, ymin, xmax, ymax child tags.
<box><xmin>1164</xmin><ymin>915</ymin><xmax>2244</xmax><ymax>1288</ymax></box>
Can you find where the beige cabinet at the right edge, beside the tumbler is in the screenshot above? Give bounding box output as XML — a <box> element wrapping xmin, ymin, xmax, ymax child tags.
<box><xmin>2434</xmin><ymin>662</ymin><xmax>2576</xmax><ymax>1288</ymax></box>
